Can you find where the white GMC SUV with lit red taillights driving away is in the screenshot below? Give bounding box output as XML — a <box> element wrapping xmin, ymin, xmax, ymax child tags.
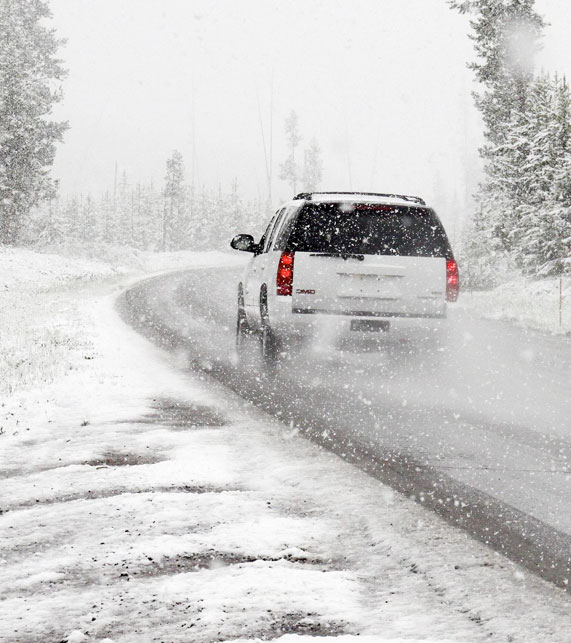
<box><xmin>231</xmin><ymin>192</ymin><xmax>459</xmax><ymax>361</ymax></box>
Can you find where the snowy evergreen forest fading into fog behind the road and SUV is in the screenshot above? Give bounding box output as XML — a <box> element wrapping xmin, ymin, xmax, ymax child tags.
<box><xmin>0</xmin><ymin>0</ymin><xmax>571</xmax><ymax>288</ymax></box>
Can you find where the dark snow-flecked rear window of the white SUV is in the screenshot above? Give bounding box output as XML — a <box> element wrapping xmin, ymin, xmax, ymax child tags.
<box><xmin>286</xmin><ymin>203</ymin><xmax>451</xmax><ymax>257</ymax></box>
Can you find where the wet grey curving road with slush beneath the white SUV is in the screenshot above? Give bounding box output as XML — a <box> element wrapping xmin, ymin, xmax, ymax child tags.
<box><xmin>123</xmin><ymin>262</ymin><xmax>571</xmax><ymax>589</ymax></box>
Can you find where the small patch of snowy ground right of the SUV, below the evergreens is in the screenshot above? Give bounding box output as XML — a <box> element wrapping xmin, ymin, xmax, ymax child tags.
<box><xmin>457</xmin><ymin>277</ymin><xmax>571</xmax><ymax>335</ymax></box>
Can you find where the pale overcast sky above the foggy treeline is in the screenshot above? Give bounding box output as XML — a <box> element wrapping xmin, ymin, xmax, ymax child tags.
<box><xmin>50</xmin><ymin>0</ymin><xmax>571</xmax><ymax>231</ymax></box>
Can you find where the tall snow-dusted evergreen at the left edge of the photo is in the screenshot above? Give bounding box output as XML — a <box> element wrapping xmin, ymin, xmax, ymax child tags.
<box><xmin>0</xmin><ymin>0</ymin><xmax>67</xmax><ymax>244</ymax></box>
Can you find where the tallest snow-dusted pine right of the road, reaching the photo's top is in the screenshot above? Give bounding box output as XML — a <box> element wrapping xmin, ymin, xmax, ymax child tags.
<box><xmin>449</xmin><ymin>0</ymin><xmax>549</xmax><ymax>274</ymax></box>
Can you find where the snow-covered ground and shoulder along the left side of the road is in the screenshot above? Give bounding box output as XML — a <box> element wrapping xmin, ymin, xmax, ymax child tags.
<box><xmin>0</xmin><ymin>250</ymin><xmax>571</xmax><ymax>643</ymax></box>
